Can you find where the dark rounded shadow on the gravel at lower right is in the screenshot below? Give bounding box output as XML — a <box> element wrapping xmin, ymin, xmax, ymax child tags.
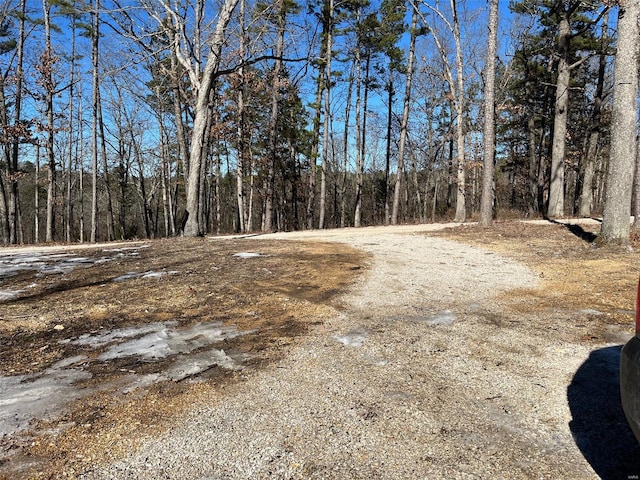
<box><xmin>567</xmin><ymin>345</ymin><xmax>640</xmax><ymax>480</ymax></box>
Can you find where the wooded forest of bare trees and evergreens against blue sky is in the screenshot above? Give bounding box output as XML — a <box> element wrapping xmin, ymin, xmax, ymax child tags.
<box><xmin>0</xmin><ymin>0</ymin><xmax>640</xmax><ymax>244</ymax></box>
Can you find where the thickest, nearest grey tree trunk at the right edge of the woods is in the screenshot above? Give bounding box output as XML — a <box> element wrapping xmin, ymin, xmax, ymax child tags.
<box><xmin>598</xmin><ymin>0</ymin><xmax>640</xmax><ymax>245</ymax></box>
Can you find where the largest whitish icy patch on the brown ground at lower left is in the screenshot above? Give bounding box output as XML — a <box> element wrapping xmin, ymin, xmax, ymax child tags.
<box><xmin>0</xmin><ymin>322</ymin><xmax>252</xmax><ymax>438</ymax></box>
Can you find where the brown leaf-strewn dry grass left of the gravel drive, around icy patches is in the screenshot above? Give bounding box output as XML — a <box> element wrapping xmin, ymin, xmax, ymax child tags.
<box><xmin>0</xmin><ymin>239</ymin><xmax>366</xmax><ymax>478</ymax></box>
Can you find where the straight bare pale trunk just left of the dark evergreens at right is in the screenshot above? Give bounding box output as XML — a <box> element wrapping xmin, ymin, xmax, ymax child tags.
<box><xmin>480</xmin><ymin>0</ymin><xmax>499</xmax><ymax>227</ymax></box>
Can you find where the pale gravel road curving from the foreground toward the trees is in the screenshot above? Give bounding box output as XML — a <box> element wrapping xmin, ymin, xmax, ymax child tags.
<box><xmin>83</xmin><ymin>227</ymin><xmax>627</xmax><ymax>479</ymax></box>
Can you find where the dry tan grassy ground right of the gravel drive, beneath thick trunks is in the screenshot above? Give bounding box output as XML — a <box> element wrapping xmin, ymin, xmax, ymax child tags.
<box><xmin>442</xmin><ymin>222</ymin><xmax>640</xmax><ymax>340</ymax></box>
